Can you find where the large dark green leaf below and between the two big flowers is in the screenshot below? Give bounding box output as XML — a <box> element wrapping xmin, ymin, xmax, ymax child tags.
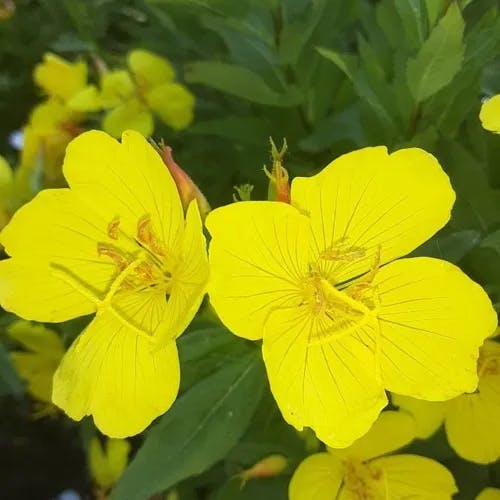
<box><xmin>111</xmin><ymin>352</ymin><xmax>265</xmax><ymax>500</ymax></box>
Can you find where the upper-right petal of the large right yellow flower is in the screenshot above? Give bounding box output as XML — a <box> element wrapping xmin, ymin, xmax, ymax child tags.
<box><xmin>292</xmin><ymin>147</ymin><xmax>455</xmax><ymax>283</ymax></box>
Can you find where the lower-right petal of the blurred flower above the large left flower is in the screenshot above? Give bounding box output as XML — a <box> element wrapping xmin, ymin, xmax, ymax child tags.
<box><xmin>146</xmin><ymin>83</ymin><xmax>194</xmax><ymax>130</ymax></box>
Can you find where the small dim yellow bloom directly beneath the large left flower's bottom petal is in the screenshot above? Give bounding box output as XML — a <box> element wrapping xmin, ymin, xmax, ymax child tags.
<box><xmin>88</xmin><ymin>437</ymin><xmax>130</xmax><ymax>493</ymax></box>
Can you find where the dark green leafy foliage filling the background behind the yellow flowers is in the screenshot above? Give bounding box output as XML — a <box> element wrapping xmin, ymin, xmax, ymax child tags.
<box><xmin>0</xmin><ymin>0</ymin><xmax>500</xmax><ymax>500</ymax></box>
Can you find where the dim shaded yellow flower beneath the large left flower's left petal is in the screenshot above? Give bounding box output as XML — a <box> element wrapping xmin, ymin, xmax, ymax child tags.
<box><xmin>7</xmin><ymin>320</ymin><xmax>64</xmax><ymax>405</ymax></box>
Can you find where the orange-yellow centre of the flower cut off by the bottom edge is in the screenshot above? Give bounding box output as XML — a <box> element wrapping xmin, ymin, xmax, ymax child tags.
<box><xmin>344</xmin><ymin>460</ymin><xmax>386</xmax><ymax>500</ymax></box>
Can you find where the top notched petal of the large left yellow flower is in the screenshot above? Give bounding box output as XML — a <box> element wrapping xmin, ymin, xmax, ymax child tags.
<box><xmin>64</xmin><ymin>130</ymin><xmax>184</xmax><ymax>251</ymax></box>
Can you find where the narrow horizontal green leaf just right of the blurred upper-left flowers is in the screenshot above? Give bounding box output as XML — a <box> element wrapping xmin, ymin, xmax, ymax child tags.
<box><xmin>186</xmin><ymin>61</ymin><xmax>302</xmax><ymax>107</ymax></box>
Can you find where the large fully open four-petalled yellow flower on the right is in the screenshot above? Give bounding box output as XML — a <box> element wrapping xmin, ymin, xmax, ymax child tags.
<box><xmin>206</xmin><ymin>147</ymin><xmax>497</xmax><ymax>447</ymax></box>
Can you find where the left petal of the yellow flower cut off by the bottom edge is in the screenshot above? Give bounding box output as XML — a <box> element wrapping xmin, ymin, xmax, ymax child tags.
<box><xmin>288</xmin><ymin>453</ymin><xmax>343</xmax><ymax>500</ymax></box>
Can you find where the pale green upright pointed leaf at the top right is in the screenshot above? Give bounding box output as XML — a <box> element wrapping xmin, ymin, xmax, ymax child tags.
<box><xmin>406</xmin><ymin>3</ymin><xmax>465</xmax><ymax>103</ymax></box>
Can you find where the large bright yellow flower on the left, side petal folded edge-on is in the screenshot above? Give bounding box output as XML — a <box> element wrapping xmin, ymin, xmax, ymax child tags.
<box><xmin>0</xmin><ymin>131</ymin><xmax>208</xmax><ymax>438</ymax></box>
